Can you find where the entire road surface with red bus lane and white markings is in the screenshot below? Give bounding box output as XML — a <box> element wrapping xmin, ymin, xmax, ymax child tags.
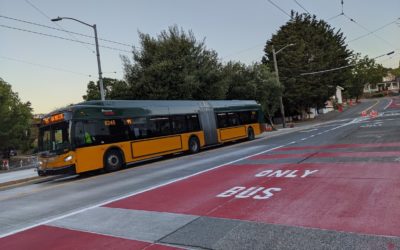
<box><xmin>0</xmin><ymin>97</ymin><xmax>400</xmax><ymax>249</ymax></box>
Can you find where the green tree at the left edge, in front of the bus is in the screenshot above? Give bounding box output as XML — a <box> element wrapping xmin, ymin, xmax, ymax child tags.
<box><xmin>0</xmin><ymin>78</ymin><xmax>32</xmax><ymax>150</ymax></box>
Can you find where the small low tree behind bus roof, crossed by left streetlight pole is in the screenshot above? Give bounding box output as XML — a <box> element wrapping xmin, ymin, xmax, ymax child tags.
<box><xmin>83</xmin><ymin>78</ymin><xmax>130</xmax><ymax>101</ymax></box>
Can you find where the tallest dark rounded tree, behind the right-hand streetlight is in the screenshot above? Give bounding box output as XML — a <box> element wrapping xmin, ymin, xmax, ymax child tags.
<box><xmin>262</xmin><ymin>12</ymin><xmax>351</xmax><ymax>114</ymax></box>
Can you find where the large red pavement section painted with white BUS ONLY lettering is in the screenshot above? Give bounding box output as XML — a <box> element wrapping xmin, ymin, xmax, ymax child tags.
<box><xmin>106</xmin><ymin>146</ymin><xmax>400</xmax><ymax>236</ymax></box>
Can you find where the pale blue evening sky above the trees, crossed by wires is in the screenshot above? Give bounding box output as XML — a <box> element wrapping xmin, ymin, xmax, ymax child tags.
<box><xmin>0</xmin><ymin>0</ymin><xmax>400</xmax><ymax>114</ymax></box>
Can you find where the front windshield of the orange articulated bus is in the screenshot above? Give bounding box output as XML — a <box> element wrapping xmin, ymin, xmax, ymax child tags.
<box><xmin>39</xmin><ymin>122</ymin><xmax>71</xmax><ymax>154</ymax></box>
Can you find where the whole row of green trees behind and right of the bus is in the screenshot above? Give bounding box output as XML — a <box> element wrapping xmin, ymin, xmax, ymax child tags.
<box><xmin>78</xmin><ymin>12</ymin><xmax>385</xmax><ymax>117</ymax></box>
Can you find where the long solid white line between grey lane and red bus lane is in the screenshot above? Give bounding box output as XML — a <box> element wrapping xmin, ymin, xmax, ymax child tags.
<box><xmin>0</xmin><ymin>119</ymin><xmax>357</xmax><ymax>239</ymax></box>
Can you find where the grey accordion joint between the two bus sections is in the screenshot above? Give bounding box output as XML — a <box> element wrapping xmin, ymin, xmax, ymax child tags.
<box><xmin>199</xmin><ymin>107</ymin><xmax>218</xmax><ymax>145</ymax></box>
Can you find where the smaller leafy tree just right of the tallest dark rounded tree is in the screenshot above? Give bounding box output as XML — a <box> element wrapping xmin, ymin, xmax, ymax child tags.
<box><xmin>345</xmin><ymin>54</ymin><xmax>387</xmax><ymax>99</ymax></box>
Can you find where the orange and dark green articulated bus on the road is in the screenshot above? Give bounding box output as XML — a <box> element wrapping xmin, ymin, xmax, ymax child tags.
<box><xmin>37</xmin><ymin>100</ymin><xmax>263</xmax><ymax>176</ymax></box>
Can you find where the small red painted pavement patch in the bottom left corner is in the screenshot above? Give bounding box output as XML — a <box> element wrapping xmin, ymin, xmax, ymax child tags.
<box><xmin>0</xmin><ymin>226</ymin><xmax>178</xmax><ymax>250</ymax></box>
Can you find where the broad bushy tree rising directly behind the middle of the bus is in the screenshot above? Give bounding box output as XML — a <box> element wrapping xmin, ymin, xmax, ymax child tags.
<box><xmin>122</xmin><ymin>26</ymin><xmax>225</xmax><ymax>100</ymax></box>
